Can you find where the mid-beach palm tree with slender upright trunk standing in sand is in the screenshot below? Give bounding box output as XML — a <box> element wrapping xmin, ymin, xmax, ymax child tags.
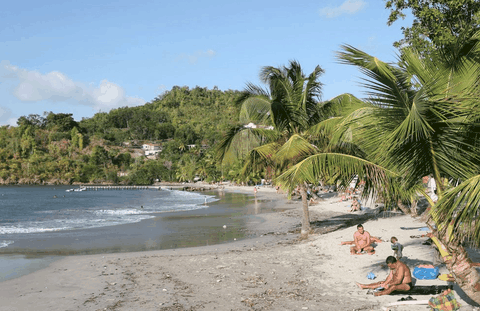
<box><xmin>217</xmin><ymin>61</ymin><xmax>364</xmax><ymax>237</ymax></box>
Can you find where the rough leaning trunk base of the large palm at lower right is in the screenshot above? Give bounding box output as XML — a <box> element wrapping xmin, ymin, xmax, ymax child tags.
<box><xmin>439</xmin><ymin>238</ymin><xmax>480</xmax><ymax>304</ymax></box>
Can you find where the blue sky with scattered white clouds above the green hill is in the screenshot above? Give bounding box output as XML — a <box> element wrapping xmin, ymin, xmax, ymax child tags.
<box><xmin>0</xmin><ymin>0</ymin><xmax>412</xmax><ymax>126</ymax></box>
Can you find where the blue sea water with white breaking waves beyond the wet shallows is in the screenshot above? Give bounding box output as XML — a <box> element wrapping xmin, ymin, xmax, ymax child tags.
<box><xmin>0</xmin><ymin>186</ymin><xmax>218</xmax><ymax>249</ymax></box>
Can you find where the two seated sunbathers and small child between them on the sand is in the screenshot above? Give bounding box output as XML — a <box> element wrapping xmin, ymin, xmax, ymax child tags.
<box><xmin>341</xmin><ymin>224</ymin><xmax>413</xmax><ymax>296</ymax></box>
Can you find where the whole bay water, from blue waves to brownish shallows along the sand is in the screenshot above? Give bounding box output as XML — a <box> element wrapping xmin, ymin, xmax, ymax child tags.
<box><xmin>0</xmin><ymin>186</ymin><xmax>275</xmax><ymax>281</ymax></box>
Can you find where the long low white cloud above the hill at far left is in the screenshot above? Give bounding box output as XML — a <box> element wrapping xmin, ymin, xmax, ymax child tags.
<box><xmin>0</xmin><ymin>61</ymin><xmax>145</xmax><ymax>111</ymax></box>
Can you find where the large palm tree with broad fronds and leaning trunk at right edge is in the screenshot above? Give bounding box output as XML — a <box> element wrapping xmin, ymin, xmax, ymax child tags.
<box><xmin>278</xmin><ymin>36</ymin><xmax>480</xmax><ymax>303</ymax></box>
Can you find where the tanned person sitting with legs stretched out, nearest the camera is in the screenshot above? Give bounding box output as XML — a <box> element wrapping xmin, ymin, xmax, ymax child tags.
<box><xmin>356</xmin><ymin>256</ymin><xmax>413</xmax><ymax>296</ymax></box>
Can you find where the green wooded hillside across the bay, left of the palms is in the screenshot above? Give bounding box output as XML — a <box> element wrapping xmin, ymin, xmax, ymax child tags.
<box><xmin>0</xmin><ymin>87</ymin><xmax>241</xmax><ymax>185</ymax></box>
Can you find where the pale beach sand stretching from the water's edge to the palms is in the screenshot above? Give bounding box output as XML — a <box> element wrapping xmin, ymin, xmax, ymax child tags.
<box><xmin>0</xmin><ymin>186</ymin><xmax>479</xmax><ymax>311</ymax></box>
